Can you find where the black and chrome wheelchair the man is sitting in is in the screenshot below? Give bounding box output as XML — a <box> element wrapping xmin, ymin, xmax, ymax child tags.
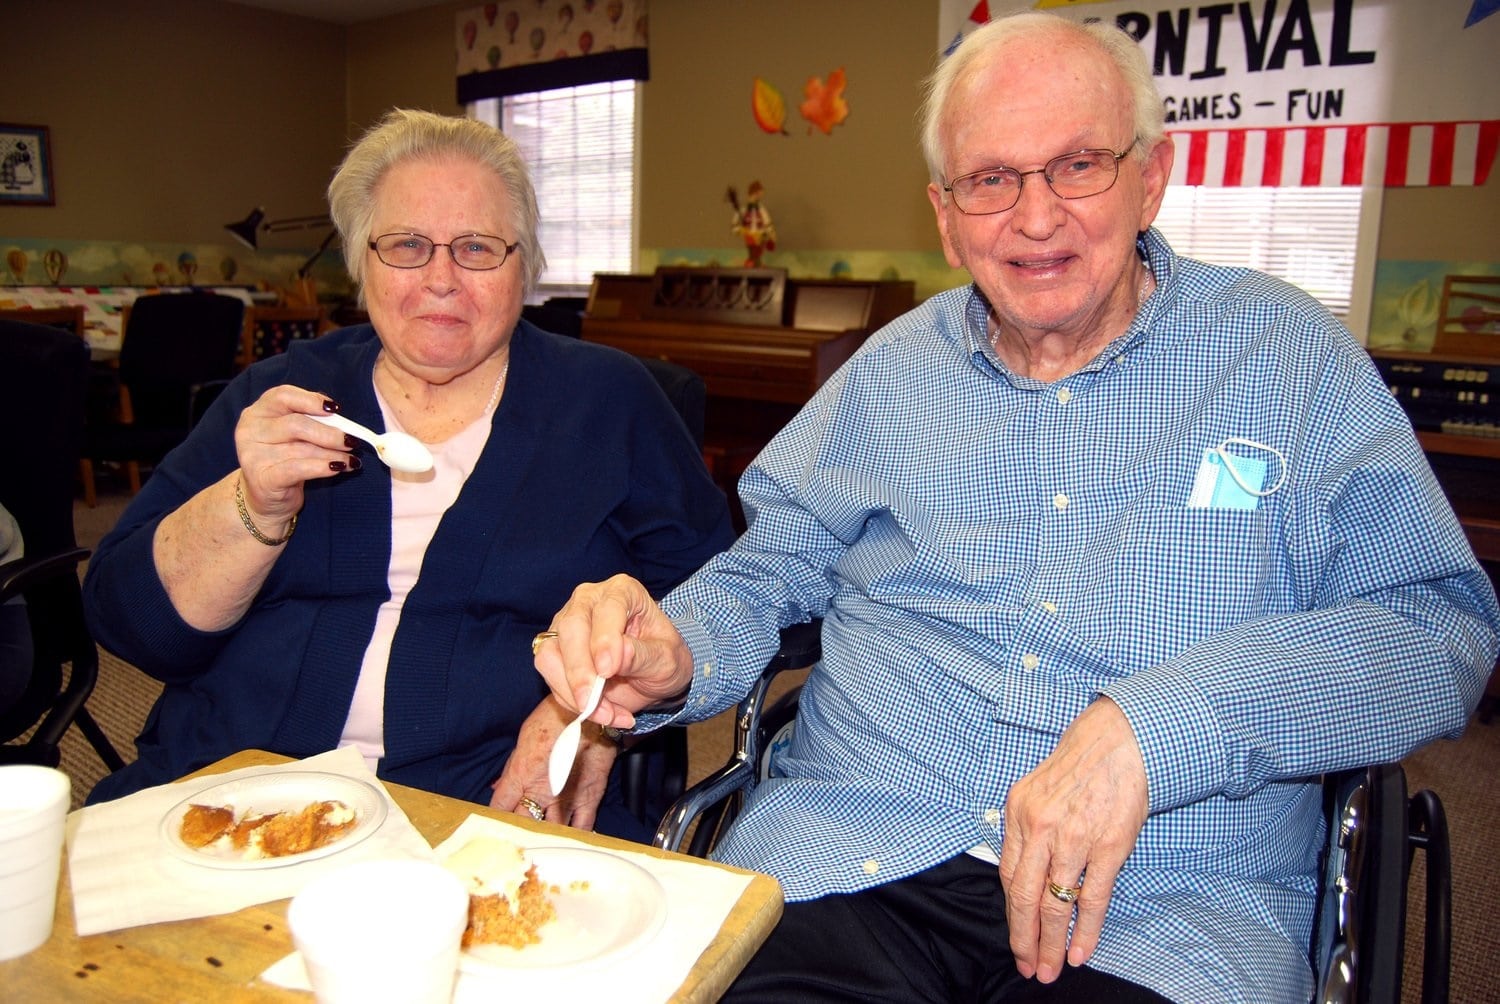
<box><xmin>654</xmin><ymin>621</ymin><xmax>1452</xmax><ymax>1004</ymax></box>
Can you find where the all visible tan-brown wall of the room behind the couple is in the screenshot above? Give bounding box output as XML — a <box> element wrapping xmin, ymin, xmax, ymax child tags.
<box><xmin>0</xmin><ymin>0</ymin><xmax>1500</xmax><ymax>274</ymax></box>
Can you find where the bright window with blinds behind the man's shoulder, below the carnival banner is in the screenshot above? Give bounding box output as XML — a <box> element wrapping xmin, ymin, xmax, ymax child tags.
<box><xmin>1155</xmin><ymin>185</ymin><xmax>1380</xmax><ymax>336</ymax></box>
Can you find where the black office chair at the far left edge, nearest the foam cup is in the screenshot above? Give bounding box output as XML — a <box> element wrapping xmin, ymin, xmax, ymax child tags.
<box><xmin>0</xmin><ymin>321</ymin><xmax>125</xmax><ymax>770</ymax></box>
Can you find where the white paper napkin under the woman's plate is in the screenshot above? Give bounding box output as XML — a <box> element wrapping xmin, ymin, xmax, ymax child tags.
<box><xmin>68</xmin><ymin>746</ymin><xmax>434</xmax><ymax>936</ymax></box>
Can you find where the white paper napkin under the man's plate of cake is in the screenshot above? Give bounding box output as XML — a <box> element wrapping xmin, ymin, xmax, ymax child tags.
<box><xmin>261</xmin><ymin>815</ymin><xmax>762</xmax><ymax>1004</ymax></box>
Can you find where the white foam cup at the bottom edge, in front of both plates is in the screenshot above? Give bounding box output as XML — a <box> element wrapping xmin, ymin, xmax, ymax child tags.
<box><xmin>287</xmin><ymin>860</ymin><xmax>468</xmax><ymax>1004</ymax></box>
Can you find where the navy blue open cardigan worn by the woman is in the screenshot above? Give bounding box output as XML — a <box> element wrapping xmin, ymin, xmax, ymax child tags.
<box><xmin>84</xmin><ymin>321</ymin><xmax>732</xmax><ymax>828</ymax></box>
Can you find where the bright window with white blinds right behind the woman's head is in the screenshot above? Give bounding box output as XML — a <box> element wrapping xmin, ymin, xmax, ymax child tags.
<box><xmin>470</xmin><ymin>80</ymin><xmax>638</xmax><ymax>299</ymax></box>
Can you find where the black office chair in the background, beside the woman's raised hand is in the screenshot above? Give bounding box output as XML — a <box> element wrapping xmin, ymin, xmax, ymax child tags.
<box><xmin>83</xmin><ymin>291</ymin><xmax>245</xmax><ymax>506</ymax></box>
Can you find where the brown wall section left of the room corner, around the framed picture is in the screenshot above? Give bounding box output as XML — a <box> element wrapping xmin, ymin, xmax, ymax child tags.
<box><xmin>0</xmin><ymin>0</ymin><xmax>345</xmax><ymax>243</ymax></box>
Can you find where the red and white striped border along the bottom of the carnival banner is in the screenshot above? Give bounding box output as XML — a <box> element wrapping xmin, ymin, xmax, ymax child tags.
<box><xmin>1169</xmin><ymin>119</ymin><xmax>1500</xmax><ymax>188</ymax></box>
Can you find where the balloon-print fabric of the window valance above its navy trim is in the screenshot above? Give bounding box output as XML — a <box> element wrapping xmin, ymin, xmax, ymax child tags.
<box><xmin>455</xmin><ymin>0</ymin><xmax>650</xmax><ymax>78</ymax></box>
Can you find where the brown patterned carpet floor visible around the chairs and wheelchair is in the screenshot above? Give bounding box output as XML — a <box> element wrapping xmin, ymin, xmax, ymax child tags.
<box><xmin>52</xmin><ymin>483</ymin><xmax>1500</xmax><ymax>1004</ymax></box>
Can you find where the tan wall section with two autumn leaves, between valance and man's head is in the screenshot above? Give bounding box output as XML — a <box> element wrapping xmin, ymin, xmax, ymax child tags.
<box><xmin>641</xmin><ymin>0</ymin><xmax>939</xmax><ymax>251</ymax></box>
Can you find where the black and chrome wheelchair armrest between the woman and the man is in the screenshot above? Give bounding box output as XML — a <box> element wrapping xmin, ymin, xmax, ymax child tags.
<box><xmin>653</xmin><ymin>620</ymin><xmax>824</xmax><ymax>852</ymax></box>
